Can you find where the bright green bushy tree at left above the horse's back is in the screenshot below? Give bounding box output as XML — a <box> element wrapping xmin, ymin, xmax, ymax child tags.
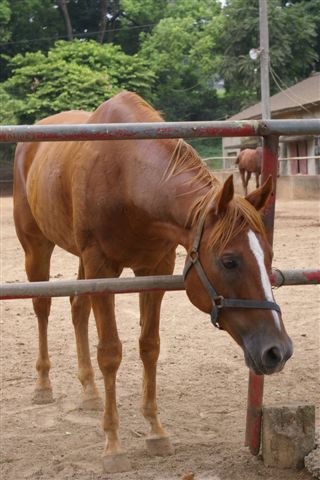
<box><xmin>0</xmin><ymin>40</ymin><xmax>153</xmax><ymax>123</ymax></box>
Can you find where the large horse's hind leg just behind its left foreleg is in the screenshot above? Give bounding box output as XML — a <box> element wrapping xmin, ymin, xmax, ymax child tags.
<box><xmin>70</xmin><ymin>260</ymin><xmax>103</xmax><ymax>410</ymax></box>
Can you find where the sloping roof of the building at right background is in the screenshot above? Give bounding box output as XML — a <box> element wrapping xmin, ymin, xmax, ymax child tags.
<box><xmin>229</xmin><ymin>72</ymin><xmax>320</xmax><ymax>120</ymax></box>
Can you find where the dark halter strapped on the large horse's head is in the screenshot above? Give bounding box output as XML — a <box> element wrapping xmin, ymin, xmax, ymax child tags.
<box><xmin>183</xmin><ymin>218</ymin><xmax>281</xmax><ymax>329</ymax></box>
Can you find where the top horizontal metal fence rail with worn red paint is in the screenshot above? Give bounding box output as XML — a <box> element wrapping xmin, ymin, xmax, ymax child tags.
<box><xmin>0</xmin><ymin>119</ymin><xmax>320</xmax><ymax>143</ymax></box>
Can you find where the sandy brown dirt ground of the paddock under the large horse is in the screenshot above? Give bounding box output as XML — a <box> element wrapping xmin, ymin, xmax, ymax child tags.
<box><xmin>0</xmin><ymin>192</ymin><xmax>320</xmax><ymax>480</ymax></box>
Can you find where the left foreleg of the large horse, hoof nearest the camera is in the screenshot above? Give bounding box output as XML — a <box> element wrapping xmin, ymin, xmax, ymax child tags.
<box><xmin>82</xmin><ymin>247</ymin><xmax>130</xmax><ymax>473</ymax></box>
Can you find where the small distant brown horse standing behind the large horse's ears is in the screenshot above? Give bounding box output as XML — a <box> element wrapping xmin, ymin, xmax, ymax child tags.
<box><xmin>236</xmin><ymin>147</ymin><xmax>262</xmax><ymax>195</ymax></box>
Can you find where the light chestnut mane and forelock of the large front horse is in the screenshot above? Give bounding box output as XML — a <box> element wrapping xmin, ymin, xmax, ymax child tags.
<box><xmin>163</xmin><ymin>139</ymin><xmax>266</xmax><ymax>252</ymax></box>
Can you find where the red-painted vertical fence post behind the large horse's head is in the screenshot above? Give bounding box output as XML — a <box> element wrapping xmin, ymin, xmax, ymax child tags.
<box><xmin>245</xmin><ymin>135</ymin><xmax>279</xmax><ymax>455</ymax></box>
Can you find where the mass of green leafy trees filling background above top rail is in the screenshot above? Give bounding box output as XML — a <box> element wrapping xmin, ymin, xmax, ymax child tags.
<box><xmin>0</xmin><ymin>0</ymin><xmax>320</xmax><ymax>126</ymax></box>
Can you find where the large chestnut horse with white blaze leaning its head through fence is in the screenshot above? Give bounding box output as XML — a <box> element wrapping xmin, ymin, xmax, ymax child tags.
<box><xmin>14</xmin><ymin>92</ymin><xmax>292</xmax><ymax>472</ymax></box>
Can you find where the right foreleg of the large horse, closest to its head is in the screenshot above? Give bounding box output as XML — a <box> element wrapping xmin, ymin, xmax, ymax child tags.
<box><xmin>135</xmin><ymin>252</ymin><xmax>175</xmax><ymax>455</ymax></box>
